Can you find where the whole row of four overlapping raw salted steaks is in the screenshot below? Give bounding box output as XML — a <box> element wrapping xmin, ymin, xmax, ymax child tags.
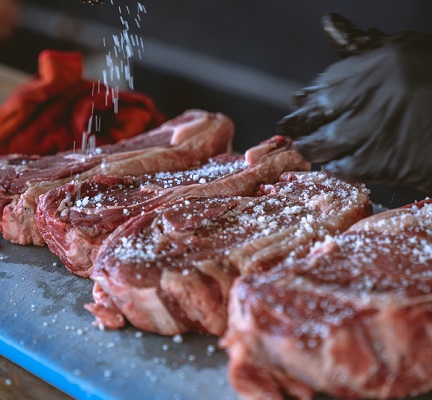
<box><xmin>0</xmin><ymin>106</ymin><xmax>432</xmax><ymax>400</ymax></box>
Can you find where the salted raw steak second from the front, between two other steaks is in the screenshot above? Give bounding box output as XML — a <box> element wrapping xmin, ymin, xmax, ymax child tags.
<box><xmin>87</xmin><ymin>172</ymin><xmax>371</xmax><ymax>335</ymax></box>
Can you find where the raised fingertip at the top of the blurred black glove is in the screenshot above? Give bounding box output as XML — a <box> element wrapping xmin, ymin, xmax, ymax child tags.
<box><xmin>322</xmin><ymin>13</ymin><xmax>385</xmax><ymax>57</ymax></box>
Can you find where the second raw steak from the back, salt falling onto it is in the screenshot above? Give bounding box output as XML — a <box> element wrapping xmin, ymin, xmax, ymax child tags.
<box><xmin>36</xmin><ymin>137</ymin><xmax>310</xmax><ymax>277</ymax></box>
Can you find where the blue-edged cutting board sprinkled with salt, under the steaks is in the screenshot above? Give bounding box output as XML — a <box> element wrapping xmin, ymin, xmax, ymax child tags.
<box><xmin>0</xmin><ymin>238</ymin><xmax>236</xmax><ymax>400</ymax></box>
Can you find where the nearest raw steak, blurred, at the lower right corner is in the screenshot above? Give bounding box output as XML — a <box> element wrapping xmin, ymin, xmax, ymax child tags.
<box><xmin>222</xmin><ymin>200</ymin><xmax>432</xmax><ymax>400</ymax></box>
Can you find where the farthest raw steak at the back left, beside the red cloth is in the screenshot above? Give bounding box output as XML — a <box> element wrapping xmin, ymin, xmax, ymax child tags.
<box><xmin>0</xmin><ymin>110</ymin><xmax>234</xmax><ymax>245</ymax></box>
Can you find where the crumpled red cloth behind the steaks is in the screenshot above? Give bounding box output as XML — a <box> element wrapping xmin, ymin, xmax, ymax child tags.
<box><xmin>0</xmin><ymin>50</ymin><xmax>165</xmax><ymax>154</ymax></box>
